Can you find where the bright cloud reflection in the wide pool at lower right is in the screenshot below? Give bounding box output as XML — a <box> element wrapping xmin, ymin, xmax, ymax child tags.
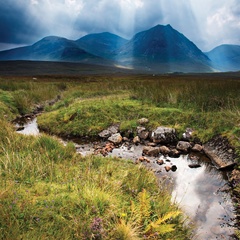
<box><xmin>171</xmin><ymin>156</ymin><xmax>234</xmax><ymax>239</ymax></box>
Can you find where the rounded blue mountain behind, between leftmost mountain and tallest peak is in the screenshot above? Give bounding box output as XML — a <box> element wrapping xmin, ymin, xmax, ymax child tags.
<box><xmin>76</xmin><ymin>32</ymin><xmax>128</xmax><ymax>59</ymax></box>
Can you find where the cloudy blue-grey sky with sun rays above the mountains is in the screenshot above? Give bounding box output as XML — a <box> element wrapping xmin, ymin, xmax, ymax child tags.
<box><xmin>0</xmin><ymin>0</ymin><xmax>240</xmax><ymax>51</ymax></box>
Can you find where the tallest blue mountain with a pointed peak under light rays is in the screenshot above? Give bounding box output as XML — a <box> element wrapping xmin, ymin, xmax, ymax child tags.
<box><xmin>116</xmin><ymin>25</ymin><xmax>212</xmax><ymax>72</ymax></box>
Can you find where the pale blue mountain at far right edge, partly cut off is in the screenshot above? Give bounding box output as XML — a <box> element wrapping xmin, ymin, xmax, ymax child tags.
<box><xmin>205</xmin><ymin>44</ymin><xmax>240</xmax><ymax>71</ymax></box>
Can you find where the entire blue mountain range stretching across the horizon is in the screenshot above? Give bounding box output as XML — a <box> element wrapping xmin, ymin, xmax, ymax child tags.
<box><xmin>0</xmin><ymin>25</ymin><xmax>240</xmax><ymax>72</ymax></box>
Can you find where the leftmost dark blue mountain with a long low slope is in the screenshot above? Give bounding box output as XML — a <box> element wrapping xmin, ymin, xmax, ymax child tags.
<box><xmin>0</xmin><ymin>36</ymin><xmax>100</xmax><ymax>61</ymax></box>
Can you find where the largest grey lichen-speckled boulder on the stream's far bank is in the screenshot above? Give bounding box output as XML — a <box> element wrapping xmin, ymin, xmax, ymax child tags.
<box><xmin>151</xmin><ymin>127</ymin><xmax>177</xmax><ymax>143</ymax></box>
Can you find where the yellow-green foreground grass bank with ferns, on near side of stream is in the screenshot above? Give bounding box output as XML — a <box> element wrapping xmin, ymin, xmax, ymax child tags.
<box><xmin>0</xmin><ymin>121</ymin><xmax>190</xmax><ymax>239</ymax></box>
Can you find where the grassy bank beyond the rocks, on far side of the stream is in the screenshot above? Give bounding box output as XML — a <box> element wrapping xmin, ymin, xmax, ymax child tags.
<box><xmin>36</xmin><ymin>75</ymin><xmax>240</xmax><ymax>146</ymax></box>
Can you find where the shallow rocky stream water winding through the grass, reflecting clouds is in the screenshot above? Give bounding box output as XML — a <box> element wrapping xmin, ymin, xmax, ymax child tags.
<box><xmin>18</xmin><ymin>118</ymin><xmax>236</xmax><ymax>240</ymax></box>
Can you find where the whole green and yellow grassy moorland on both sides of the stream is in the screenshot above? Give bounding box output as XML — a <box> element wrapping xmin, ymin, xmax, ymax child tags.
<box><xmin>0</xmin><ymin>69</ymin><xmax>240</xmax><ymax>240</ymax></box>
